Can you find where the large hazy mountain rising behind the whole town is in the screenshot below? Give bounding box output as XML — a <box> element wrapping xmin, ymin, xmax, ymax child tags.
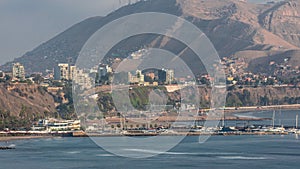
<box><xmin>1</xmin><ymin>0</ymin><xmax>300</xmax><ymax>73</ymax></box>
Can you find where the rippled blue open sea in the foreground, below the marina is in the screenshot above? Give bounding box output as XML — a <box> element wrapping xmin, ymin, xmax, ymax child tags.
<box><xmin>0</xmin><ymin>135</ymin><xmax>300</xmax><ymax>169</ymax></box>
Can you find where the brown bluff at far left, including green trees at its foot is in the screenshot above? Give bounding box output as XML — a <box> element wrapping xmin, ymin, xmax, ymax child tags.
<box><xmin>0</xmin><ymin>83</ymin><xmax>57</xmax><ymax>130</ymax></box>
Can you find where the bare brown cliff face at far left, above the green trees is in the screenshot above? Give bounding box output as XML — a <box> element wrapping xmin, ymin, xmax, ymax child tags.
<box><xmin>0</xmin><ymin>84</ymin><xmax>56</xmax><ymax>117</ymax></box>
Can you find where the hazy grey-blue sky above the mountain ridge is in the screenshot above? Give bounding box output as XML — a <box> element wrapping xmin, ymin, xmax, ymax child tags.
<box><xmin>0</xmin><ymin>0</ymin><xmax>263</xmax><ymax>65</ymax></box>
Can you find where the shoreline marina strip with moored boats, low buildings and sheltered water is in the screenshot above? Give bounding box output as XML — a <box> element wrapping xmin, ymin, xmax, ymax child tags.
<box><xmin>0</xmin><ymin>110</ymin><xmax>300</xmax><ymax>138</ymax></box>
